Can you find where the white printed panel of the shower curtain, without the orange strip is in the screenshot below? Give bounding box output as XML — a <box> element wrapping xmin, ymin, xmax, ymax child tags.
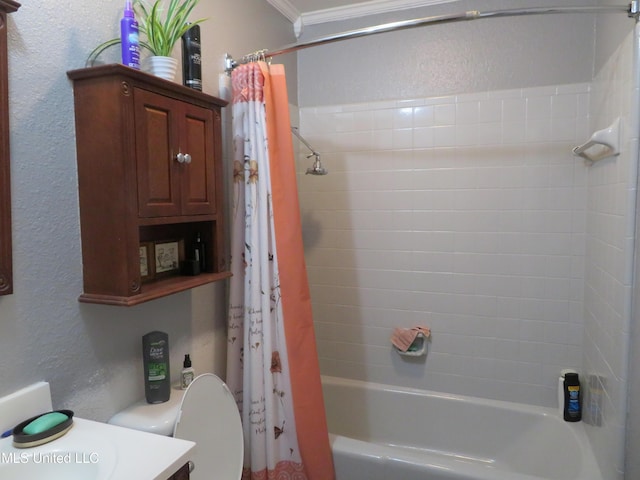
<box><xmin>227</xmin><ymin>65</ymin><xmax>304</xmax><ymax>480</ymax></box>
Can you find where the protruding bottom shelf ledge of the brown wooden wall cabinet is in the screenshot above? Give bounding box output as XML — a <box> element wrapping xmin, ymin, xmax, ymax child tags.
<box><xmin>78</xmin><ymin>272</ymin><xmax>231</xmax><ymax>307</ymax></box>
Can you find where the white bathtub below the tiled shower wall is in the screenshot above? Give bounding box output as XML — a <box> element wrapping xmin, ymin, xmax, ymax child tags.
<box><xmin>322</xmin><ymin>376</ymin><xmax>603</xmax><ymax>480</ymax></box>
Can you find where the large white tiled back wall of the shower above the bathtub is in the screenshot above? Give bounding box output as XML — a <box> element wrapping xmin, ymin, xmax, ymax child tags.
<box><xmin>299</xmin><ymin>84</ymin><xmax>590</xmax><ymax>406</ymax></box>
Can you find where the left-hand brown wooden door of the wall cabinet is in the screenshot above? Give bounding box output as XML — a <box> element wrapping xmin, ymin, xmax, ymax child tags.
<box><xmin>132</xmin><ymin>88</ymin><xmax>182</xmax><ymax>217</ymax></box>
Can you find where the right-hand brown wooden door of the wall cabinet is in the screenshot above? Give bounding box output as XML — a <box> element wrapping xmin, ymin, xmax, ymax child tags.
<box><xmin>180</xmin><ymin>104</ymin><xmax>215</xmax><ymax>215</ymax></box>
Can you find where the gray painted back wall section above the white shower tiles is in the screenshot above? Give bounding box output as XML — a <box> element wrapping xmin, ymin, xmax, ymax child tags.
<box><xmin>298</xmin><ymin>0</ymin><xmax>608</xmax><ymax>106</ymax></box>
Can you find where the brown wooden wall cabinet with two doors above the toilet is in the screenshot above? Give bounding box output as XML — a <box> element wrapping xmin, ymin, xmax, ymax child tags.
<box><xmin>68</xmin><ymin>65</ymin><xmax>230</xmax><ymax>305</ymax></box>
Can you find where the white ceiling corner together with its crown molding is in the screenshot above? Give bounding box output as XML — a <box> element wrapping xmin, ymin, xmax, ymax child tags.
<box><xmin>267</xmin><ymin>0</ymin><xmax>455</xmax><ymax>35</ymax></box>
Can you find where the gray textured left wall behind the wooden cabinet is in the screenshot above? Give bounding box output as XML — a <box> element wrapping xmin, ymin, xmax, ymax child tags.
<box><xmin>0</xmin><ymin>0</ymin><xmax>297</xmax><ymax>420</ymax></box>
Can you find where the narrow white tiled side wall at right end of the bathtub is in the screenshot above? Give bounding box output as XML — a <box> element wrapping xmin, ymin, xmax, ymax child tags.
<box><xmin>583</xmin><ymin>28</ymin><xmax>640</xmax><ymax>478</ymax></box>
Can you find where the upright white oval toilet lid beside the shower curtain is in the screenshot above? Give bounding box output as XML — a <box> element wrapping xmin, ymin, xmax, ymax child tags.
<box><xmin>173</xmin><ymin>373</ymin><xmax>244</xmax><ymax>480</ymax></box>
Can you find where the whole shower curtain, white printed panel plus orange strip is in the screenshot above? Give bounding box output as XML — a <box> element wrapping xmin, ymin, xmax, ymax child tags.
<box><xmin>227</xmin><ymin>62</ymin><xmax>335</xmax><ymax>480</ymax></box>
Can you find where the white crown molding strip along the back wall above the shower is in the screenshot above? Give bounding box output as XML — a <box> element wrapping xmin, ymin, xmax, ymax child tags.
<box><xmin>298</xmin><ymin>0</ymin><xmax>456</xmax><ymax>25</ymax></box>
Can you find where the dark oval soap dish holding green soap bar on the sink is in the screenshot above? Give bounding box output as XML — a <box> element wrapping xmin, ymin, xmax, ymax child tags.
<box><xmin>12</xmin><ymin>410</ymin><xmax>73</xmax><ymax>448</ymax></box>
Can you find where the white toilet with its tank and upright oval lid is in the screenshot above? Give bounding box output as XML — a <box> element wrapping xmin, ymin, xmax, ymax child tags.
<box><xmin>108</xmin><ymin>373</ymin><xmax>244</xmax><ymax>480</ymax></box>
